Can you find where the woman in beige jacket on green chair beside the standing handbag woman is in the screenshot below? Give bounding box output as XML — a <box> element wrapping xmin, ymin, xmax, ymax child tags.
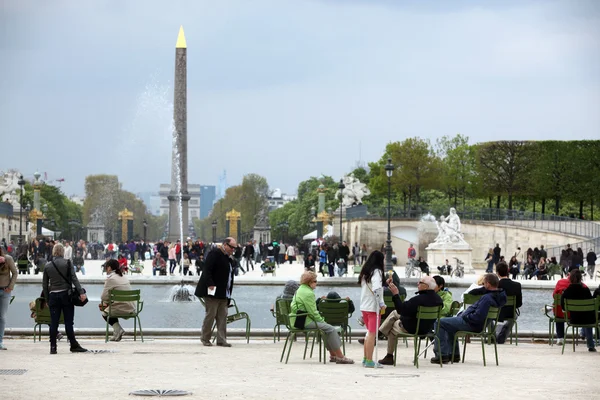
<box><xmin>99</xmin><ymin>259</ymin><xmax>135</xmax><ymax>342</ymax></box>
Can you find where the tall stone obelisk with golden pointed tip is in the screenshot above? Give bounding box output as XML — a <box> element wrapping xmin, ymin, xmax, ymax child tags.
<box><xmin>167</xmin><ymin>26</ymin><xmax>190</xmax><ymax>242</ymax></box>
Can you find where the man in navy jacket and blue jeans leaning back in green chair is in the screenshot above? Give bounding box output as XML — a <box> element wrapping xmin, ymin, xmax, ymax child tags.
<box><xmin>431</xmin><ymin>274</ymin><xmax>506</xmax><ymax>364</ymax></box>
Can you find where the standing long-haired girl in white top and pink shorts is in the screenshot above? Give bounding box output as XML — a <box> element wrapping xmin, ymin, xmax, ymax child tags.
<box><xmin>358</xmin><ymin>250</ymin><xmax>385</xmax><ymax>368</ymax></box>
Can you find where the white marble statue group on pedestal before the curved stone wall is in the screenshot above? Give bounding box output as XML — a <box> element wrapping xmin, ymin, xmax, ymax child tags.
<box><xmin>421</xmin><ymin>208</ymin><xmax>475</xmax><ymax>273</ymax></box>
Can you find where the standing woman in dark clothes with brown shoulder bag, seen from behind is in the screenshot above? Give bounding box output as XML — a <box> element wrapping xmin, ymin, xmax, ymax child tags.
<box><xmin>43</xmin><ymin>243</ymin><xmax>87</xmax><ymax>354</ymax></box>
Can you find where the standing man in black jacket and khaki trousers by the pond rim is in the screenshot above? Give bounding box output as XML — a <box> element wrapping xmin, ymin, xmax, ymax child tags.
<box><xmin>195</xmin><ymin>237</ymin><xmax>237</xmax><ymax>347</ymax></box>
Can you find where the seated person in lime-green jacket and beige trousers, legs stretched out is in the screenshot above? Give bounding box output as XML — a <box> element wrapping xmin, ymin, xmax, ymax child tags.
<box><xmin>290</xmin><ymin>271</ymin><xmax>354</xmax><ymax>364</ymax></box>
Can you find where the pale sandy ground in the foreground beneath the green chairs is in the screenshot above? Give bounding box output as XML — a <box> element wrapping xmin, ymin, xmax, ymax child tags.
<box><xmin>0</xmin><ymin>338</ymin><xmax>600</xmax><ymax>400</ymax></box>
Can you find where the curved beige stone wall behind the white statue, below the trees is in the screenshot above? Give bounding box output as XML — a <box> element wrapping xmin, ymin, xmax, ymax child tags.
<box><xmin>343</xmin><ymin>219</ymin><xmax>585</xmax><ymax>267</ymax></box>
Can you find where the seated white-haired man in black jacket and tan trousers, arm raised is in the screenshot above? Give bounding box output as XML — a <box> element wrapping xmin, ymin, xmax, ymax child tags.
<box><xmin>379</xmin><ymin>276</ymin><xmax>443</xmax><ymax>365</ymax></box>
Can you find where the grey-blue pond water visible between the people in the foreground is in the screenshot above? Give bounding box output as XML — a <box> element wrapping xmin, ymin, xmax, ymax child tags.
<box><xmin>7</xmin><ymin>284</ymin><xmax>552</xmax><ymax>331</ymax></box>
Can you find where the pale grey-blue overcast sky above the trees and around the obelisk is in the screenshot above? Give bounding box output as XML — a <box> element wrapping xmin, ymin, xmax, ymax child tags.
<box><xmin>0</xmin><ymin>0</ymin><xmax>600</xmax><ymax>198</ymax></box>
